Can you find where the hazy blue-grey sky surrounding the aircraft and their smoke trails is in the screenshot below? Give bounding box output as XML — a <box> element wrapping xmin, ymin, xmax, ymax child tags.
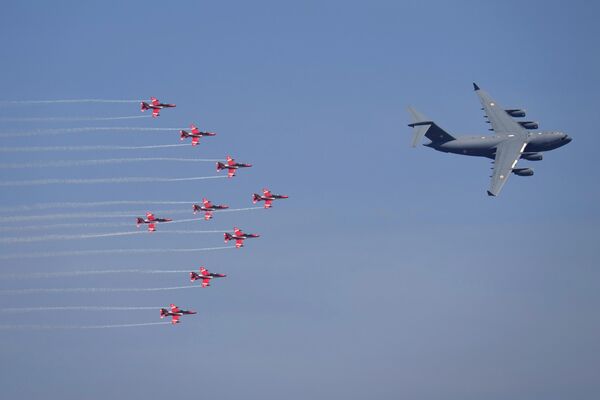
<box><xmin>0</xmin><ymin>1</ymin><xmax>600</xmax><ymax>400</ymax></box>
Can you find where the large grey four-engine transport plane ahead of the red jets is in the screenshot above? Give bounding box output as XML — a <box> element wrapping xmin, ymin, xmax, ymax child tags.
<box><xmin>408</xmin><ymin>83</ymin><xmax>572</xmax><ymax>196</ymax></box>
